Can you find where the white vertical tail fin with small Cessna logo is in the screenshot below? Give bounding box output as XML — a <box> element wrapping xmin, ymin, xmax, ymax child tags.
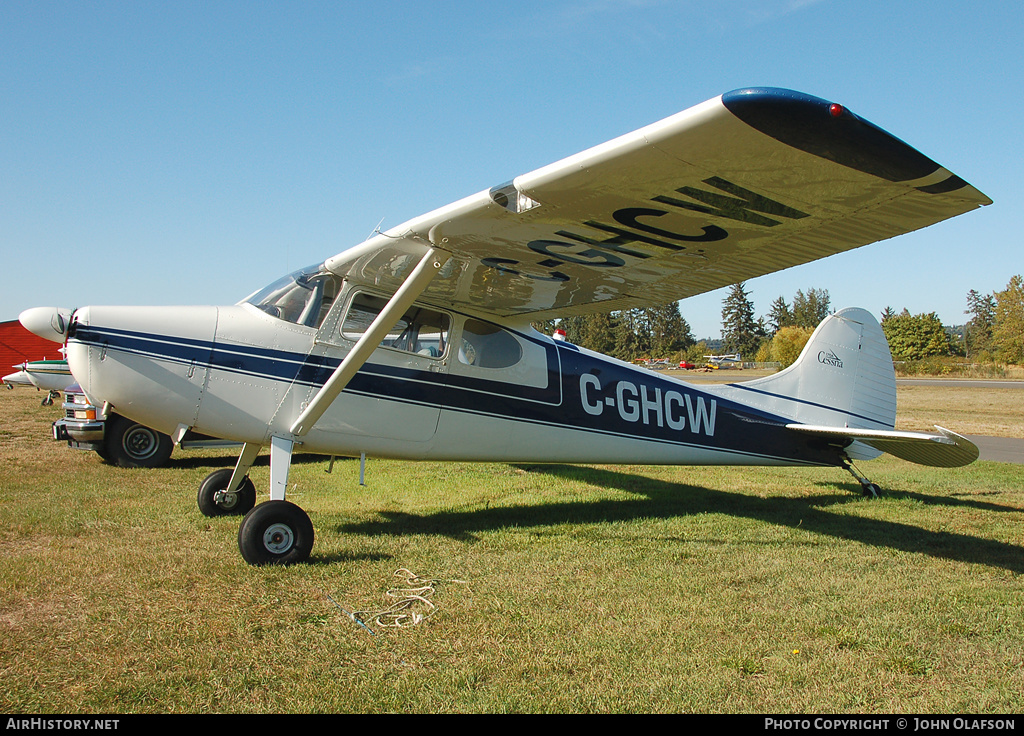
<box><xmin>733</xmin><ymin>308</ymin><xmax>896</xmax><ymax>429</ymax></box>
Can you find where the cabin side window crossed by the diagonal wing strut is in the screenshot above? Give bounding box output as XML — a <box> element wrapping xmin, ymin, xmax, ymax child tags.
<box><xmin>341</xmin><ymin>292</ymin><xmax>451</xmax><ymax>358</ymax></box>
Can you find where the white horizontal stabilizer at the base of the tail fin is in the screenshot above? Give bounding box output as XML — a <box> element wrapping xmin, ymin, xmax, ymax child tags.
<box><xmin>786</xmin><ymin>424</ymin><xmax>978</xmax><ymax>468</ymax></box>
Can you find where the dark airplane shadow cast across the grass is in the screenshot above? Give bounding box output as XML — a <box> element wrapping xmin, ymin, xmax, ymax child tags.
<box><xmin>337</xmin><ymin>465</ymin><xmax>1024</xmax><ymax>573</ymax></box>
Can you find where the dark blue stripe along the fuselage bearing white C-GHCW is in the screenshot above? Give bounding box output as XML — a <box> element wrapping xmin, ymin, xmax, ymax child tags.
<box><xmin>73</xmin><ymin>327</ymin><xmax>839</xmax><ymax>465</ymax></box>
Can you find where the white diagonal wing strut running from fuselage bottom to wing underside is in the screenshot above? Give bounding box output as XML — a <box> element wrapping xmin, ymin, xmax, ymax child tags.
<box><xmin>291</xmin><ymin>248</ymin><xmax>451</xmax><ymax>437</ymax></box>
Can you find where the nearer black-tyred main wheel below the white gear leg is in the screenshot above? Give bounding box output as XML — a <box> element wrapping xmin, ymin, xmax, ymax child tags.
<box><xmin>239</xmin><ymin>501</ymin><xmax>313</xmax><ymax>565</ymax></box>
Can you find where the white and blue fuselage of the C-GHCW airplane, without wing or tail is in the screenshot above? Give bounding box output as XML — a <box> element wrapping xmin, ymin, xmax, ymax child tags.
<box><xmin>68</xmin><ymin>290</ymin><xmax>842</xmax><ymax>465</ymax></box>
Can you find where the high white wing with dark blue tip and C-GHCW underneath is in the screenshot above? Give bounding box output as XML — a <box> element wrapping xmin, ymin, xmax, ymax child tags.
<box><xmin>325</xmin><ymin>88</ymin><xmax>991</xmax><ymax>319</ymax></box>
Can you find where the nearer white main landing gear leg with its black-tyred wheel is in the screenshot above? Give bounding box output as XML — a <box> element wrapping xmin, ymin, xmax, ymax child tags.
<box><xmin>239</xmin><ymin>437</ymin><xmax>313</xmax><ymax>565</ymax></box>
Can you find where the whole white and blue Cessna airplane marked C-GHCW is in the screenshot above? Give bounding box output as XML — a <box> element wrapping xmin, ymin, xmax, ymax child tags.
<box><xmin>20</xmin><ymin>88</ymin><xmax>990</xmax><ymax>564</ymax></box>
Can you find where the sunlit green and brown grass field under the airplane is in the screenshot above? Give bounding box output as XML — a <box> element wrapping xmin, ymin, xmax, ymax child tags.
<box><xmin>0</xmin><ymin>384</ymin><xmax>1024</xmax><ymax>713</ymax></box>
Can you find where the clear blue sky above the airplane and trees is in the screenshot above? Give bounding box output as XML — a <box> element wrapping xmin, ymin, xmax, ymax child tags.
<box><xmin>0</xmin><ymin>0</ymin><xmax>1024</xmax><ymax>338</ymax></box>
